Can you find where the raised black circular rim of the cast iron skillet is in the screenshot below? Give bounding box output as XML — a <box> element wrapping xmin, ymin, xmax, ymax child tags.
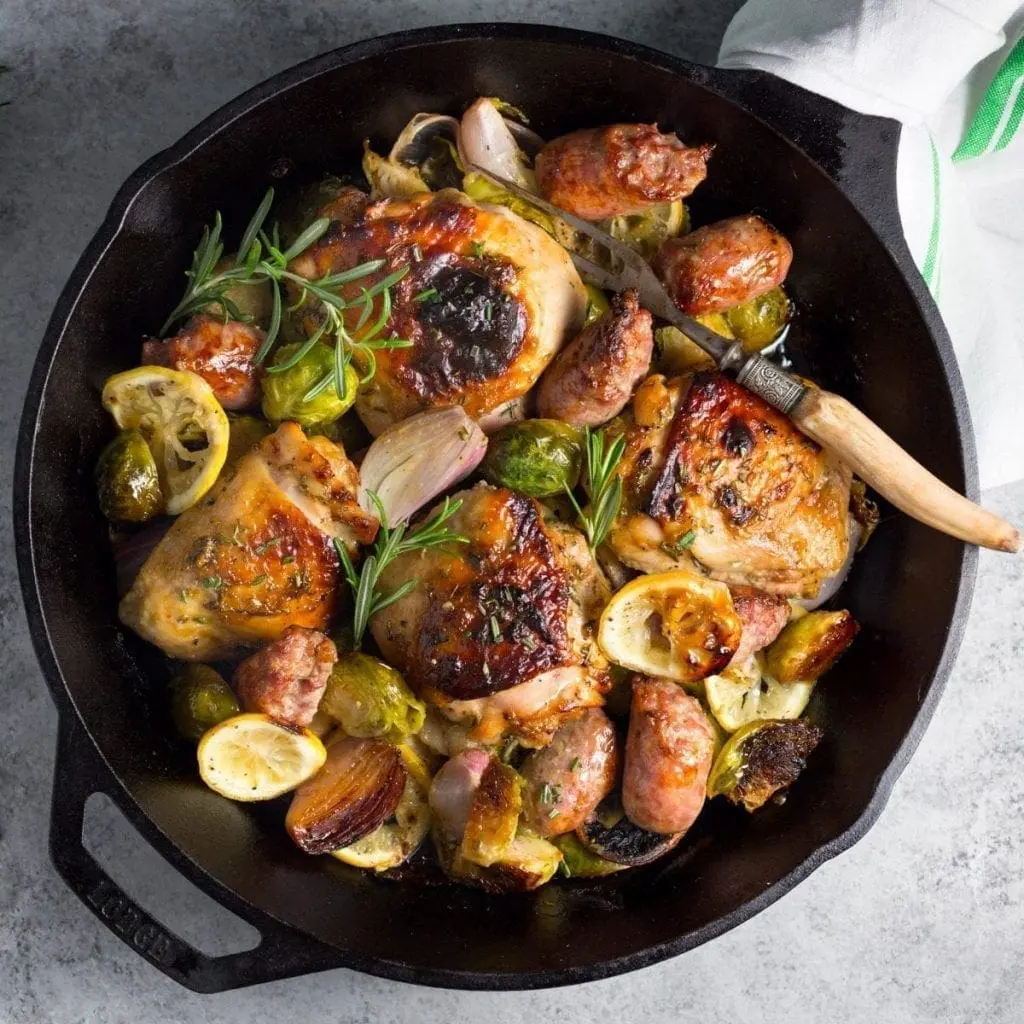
<box><xmin>12</xmin><ymin>23</ymin><xmax>978</xmax><ymax>991</ymax></box>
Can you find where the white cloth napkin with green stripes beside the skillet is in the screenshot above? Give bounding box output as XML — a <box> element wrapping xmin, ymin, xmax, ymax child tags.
<box><xmin>719</xmin><ymin>0</ymin><xmax>1024</xmax><ymax>488</ymax></box>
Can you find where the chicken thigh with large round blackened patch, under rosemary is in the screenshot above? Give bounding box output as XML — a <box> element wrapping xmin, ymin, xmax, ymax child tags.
<box><xmin>293</xmin><ymin>189</ymin><xmax>586</xmax><ymax>435</ymax></box>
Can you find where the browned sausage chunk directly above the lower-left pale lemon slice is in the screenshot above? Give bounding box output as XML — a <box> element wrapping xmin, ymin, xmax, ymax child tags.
<box><xmin>233</xmin><ymin>626</ymin><xmax>338</xmax><ymax>726</ymax></box>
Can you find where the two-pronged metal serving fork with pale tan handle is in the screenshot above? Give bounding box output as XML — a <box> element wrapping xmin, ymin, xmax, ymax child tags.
<box><xmin>469</xmin><ymin>166</ymin><xmax>1022</xmax><ymax>552</ymax></box>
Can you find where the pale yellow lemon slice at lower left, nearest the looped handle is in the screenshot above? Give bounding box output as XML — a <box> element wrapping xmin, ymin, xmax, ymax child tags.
<box><xmin>197</xmin><ymin>715</ymin><xmax>327</xmax><ymax>801</ymax></box>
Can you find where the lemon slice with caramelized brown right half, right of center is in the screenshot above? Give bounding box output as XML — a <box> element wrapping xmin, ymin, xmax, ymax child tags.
<box><xmin>597</xmin><ymin>569</ymin><xmax>742</xmax><ymax>683</ymax></box>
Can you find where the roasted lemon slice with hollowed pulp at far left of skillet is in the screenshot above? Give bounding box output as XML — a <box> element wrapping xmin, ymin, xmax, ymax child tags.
<box><xmin>103</xmin><ymin>367</ymin><xmax>230</xmax><ymax>515</ymax></box>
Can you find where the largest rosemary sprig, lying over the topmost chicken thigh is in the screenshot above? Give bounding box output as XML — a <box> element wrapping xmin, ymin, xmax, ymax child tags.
<box><xmin>160</xmin><ymin>188</ymin><xmax>412</xmax><ymax>401</ymax></box>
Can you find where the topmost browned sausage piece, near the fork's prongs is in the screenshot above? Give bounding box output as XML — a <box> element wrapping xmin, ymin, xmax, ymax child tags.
<box><xmin>536</xmin><ymin>125</ymin><xmax>714</xmax><ymax>220</ymax></box>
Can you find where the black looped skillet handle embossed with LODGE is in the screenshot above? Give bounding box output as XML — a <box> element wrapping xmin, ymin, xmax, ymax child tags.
<box><xmin>50</xmin><ymin>713</ymin><xmax>339</xmax><ymax>992</ymax></box>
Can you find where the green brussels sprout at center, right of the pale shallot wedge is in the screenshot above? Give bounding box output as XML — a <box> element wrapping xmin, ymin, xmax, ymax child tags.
<box><xmin>480</xmin><ymin>420</ymin><xmax>583</xmax><ymax>498</ymax></box>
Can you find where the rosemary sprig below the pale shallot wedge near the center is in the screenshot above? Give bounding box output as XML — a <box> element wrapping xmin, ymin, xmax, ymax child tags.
<box><xmin>334</xmin><ymin>490</ymin><xmax>469</xmax><ymax>650</ymax></box>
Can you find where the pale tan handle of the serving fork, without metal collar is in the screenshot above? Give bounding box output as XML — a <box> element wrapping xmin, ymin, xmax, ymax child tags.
<box><xmin>790</xmin><ymin>387</ymin><xmax>1021</xmax><ymax>552</ymax></box>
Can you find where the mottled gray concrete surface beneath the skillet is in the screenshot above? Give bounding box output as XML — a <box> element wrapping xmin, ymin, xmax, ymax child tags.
<box><xmin>0</xmin><ymin>0</ymin><xmax>1024</xmax><ymax>1024</ymax></box>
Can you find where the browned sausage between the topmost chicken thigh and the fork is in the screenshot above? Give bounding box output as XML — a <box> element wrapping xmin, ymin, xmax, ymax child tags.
<box><xmin>537</xmin><ymin>290</ymin><xmax>654</xmax><ymax>427</ymax></box>
